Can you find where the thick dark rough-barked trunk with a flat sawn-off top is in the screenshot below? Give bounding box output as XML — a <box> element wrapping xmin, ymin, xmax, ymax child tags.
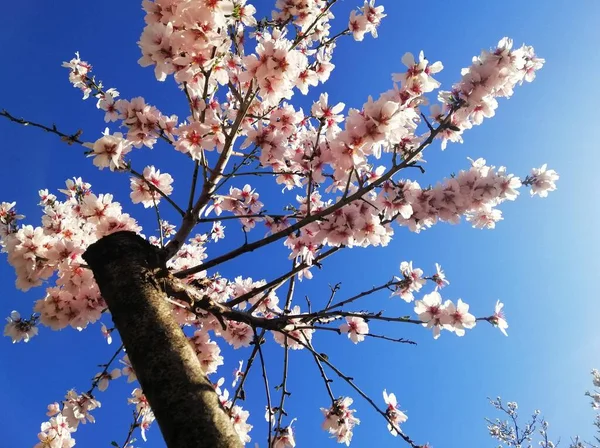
<box><xmin>83</xmin><ymin>232</ymin><xmax>242</xmax><ymax>448</ymax></box>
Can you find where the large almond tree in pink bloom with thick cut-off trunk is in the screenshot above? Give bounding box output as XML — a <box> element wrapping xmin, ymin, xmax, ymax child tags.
<box><xmin>0</xmin><ymin>0</ymin><xmax>558</xmax><ymax>448</ymax></box>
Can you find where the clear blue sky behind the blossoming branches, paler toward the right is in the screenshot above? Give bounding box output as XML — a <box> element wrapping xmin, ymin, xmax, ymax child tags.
<box><xmin>0</xmin><ymin>0</ymin><xmax>600</xmax><ymax>448</ymax></box>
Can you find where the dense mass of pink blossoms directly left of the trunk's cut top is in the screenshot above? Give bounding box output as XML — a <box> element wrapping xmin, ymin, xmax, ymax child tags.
<box><xmin>2</xmin><ymin>179</ymin><xmax>140</xmax><ymax>328</ymax></box>
